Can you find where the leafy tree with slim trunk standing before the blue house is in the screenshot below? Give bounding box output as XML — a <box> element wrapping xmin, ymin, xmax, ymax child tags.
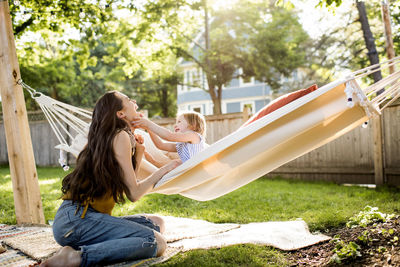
<box><xmin>144</xmin><ymin>1</ymin><xmax>307</xmax><ymax>114</ymax></box>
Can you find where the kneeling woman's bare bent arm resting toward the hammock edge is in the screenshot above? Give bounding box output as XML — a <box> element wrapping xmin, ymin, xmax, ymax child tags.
<box><xmin>113</xmin><ymin>131</ymin><xmax>178</xmax><ymax>202</ymax></box>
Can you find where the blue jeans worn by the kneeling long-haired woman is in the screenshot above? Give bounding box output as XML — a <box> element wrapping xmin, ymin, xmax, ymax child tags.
<box><xmin>53</xmin><ymin>200</ymin><xmax>160</xmax><ymax>266</ymax></box>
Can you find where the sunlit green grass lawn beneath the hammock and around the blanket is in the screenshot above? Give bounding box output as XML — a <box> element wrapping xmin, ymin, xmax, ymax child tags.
<box><xmin>0</xmin><ymin>167</ymin><xmax>400</xmax><ymax>266</ymax></box>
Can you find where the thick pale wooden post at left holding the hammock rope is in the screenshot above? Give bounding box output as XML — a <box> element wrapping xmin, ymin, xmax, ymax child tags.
<box><xmin>0</xmin><ymin>0</ymin><xmax>45</xmax><ymax>224</ymax></box>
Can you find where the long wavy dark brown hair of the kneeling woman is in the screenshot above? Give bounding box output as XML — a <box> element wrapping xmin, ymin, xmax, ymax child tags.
<box><xmin>61</xmin><ymin>91</ymin><xmax>135</xmax><ymax>203</ymax></box>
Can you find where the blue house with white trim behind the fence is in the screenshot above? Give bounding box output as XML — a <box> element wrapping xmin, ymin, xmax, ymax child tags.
<box><xmin>177</xmin><ymin>27</ymin><xmax>306</xmax><ymax>115</ymax></box>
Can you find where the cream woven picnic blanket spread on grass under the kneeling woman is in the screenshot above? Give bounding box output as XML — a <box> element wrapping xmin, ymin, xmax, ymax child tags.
<box><xmin>0</xmin><ymin>216</ymin><xmax>330</xmax><ymax>267</ymax></box>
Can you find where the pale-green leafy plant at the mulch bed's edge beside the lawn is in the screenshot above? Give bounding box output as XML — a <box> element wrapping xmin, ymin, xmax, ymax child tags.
<box><xmin>346</xmin><ymin>206</ymin><xmax>395</xmax><ymax>228</ymax></box>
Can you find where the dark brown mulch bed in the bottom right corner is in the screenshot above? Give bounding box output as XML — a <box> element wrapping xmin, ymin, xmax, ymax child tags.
<box><xmin>287</xmin><ymin>217</ymin><xmax>400</xmax><ymax>267</ymax></box>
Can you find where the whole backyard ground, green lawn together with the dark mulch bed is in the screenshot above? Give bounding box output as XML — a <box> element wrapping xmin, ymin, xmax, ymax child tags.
<box><xmin>0</xmin><ymin>167</ymin><xmax>400</xmax><ymax>266</ymax></box>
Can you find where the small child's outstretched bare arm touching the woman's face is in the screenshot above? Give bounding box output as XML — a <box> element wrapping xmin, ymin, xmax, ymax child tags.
<box><xmin>132</xmin><ymin>117</ymin><xmax>200</xmax><ymax>144</ymax></box>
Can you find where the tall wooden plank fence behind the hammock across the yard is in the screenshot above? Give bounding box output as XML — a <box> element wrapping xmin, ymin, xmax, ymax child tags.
<box><xmin>0</xmin><ymin>104</ymin><xmax>400</xmax><ymax>185</ymax></box>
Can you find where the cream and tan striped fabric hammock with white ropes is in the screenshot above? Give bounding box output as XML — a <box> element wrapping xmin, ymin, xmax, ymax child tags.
<box><xmin>22</xmin><ymin>57</ymin><xmax>400</xmax><ymax>201</ymax></box>
